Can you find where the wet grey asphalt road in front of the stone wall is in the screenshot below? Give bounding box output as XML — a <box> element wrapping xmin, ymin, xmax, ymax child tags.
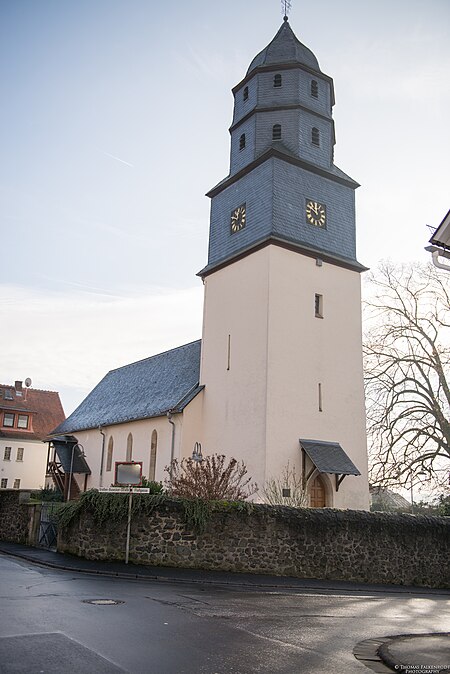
<box><xmin>0</xmin><ymin>556</ymin><xmax>450</xmax><ymax>674</ymax></box>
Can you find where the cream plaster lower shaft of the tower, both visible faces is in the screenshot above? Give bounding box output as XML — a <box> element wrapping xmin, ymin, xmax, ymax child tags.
<box><xmin>196</xmin><ymin>246</ymin><xmax>369</xmax><ymax>509</ymax></box>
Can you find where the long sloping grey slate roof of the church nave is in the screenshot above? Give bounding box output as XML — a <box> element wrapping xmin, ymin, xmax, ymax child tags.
<box><xmin>53</xmin><ymin>340</ymin><xmax>203</xmax><ymax>435</ymax></box>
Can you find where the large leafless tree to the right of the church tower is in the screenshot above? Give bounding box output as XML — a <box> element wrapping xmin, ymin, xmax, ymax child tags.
<box><xmin>364</xmin><ymin>263</ymin><xmax>450</xmax><ymax>485</ymax></box>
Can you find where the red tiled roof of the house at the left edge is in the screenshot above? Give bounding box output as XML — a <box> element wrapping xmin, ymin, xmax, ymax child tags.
<box><xmin>0</xmin><ymin>384</ymin><xmax>66</xmax><ymax>440</ymax></box>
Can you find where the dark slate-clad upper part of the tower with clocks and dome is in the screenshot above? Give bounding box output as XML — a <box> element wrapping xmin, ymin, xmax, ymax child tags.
<box><xmin>199</xmin><ymin>17</ymin><xmax>366</xmax><ymax>277</ymax></box>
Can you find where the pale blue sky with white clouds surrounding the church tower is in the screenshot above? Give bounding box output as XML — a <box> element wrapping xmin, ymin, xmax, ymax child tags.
<box><xmin>0</xmin><ymin>0</ymin><xmax>450</xmax><ymax>414</ymax></box>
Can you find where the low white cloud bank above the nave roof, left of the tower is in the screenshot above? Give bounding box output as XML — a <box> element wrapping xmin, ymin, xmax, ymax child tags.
<box><xmin>0</xmin><ymin>285</ymin><xmax>203</xmax><ymax>411</ymax></box>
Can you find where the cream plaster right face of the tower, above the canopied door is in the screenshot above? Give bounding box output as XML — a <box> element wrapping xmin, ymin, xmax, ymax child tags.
<box><xmin>266</xmin><ymin>246</ymin><xmax>369</xmax><ymax>509</ymax></box>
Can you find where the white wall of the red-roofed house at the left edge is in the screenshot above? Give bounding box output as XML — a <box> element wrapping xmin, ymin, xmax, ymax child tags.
<box><xmin>0</xmin><ymin>438</ymin><xmax>48</xmax><ymax>489</ymax></box>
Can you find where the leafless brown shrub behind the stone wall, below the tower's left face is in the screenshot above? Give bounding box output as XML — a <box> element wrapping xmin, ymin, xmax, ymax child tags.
<box><xmin>165</xmin><ymin>454</ymin><xmax>257</xmax><ymax>501</ymax></box>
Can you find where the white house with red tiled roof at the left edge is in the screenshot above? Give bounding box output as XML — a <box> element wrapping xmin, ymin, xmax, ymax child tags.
<box><xmin>0</xmin><ymin>380</ymin><xmax>65</xmax><ymax>489</ymax></box>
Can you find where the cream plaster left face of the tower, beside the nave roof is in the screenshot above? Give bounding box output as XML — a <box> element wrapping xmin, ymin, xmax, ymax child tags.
<box><xmin>199</xmin><ymin>248</ymin><xmax>269</xmax><ymax>485</ymax></box>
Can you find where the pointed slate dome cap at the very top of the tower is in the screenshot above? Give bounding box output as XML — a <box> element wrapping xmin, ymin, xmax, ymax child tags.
<box><xmin>247</xmin><ymin>20</ymin><xmax>321</xmax><ymax>75</ymax></box>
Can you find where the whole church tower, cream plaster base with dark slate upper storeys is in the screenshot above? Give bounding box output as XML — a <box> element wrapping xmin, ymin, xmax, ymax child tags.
<box><xmin>199</xmin><ymin>17</ymin><xmax>369</xmax><ymax>509</ymax></box>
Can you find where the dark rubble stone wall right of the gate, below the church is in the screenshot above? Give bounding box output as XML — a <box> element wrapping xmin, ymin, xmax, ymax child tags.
<box><xmin>58</xmin><ymin>497</ymin><xmax>450</xmax><ymax>587</ymax></box>
